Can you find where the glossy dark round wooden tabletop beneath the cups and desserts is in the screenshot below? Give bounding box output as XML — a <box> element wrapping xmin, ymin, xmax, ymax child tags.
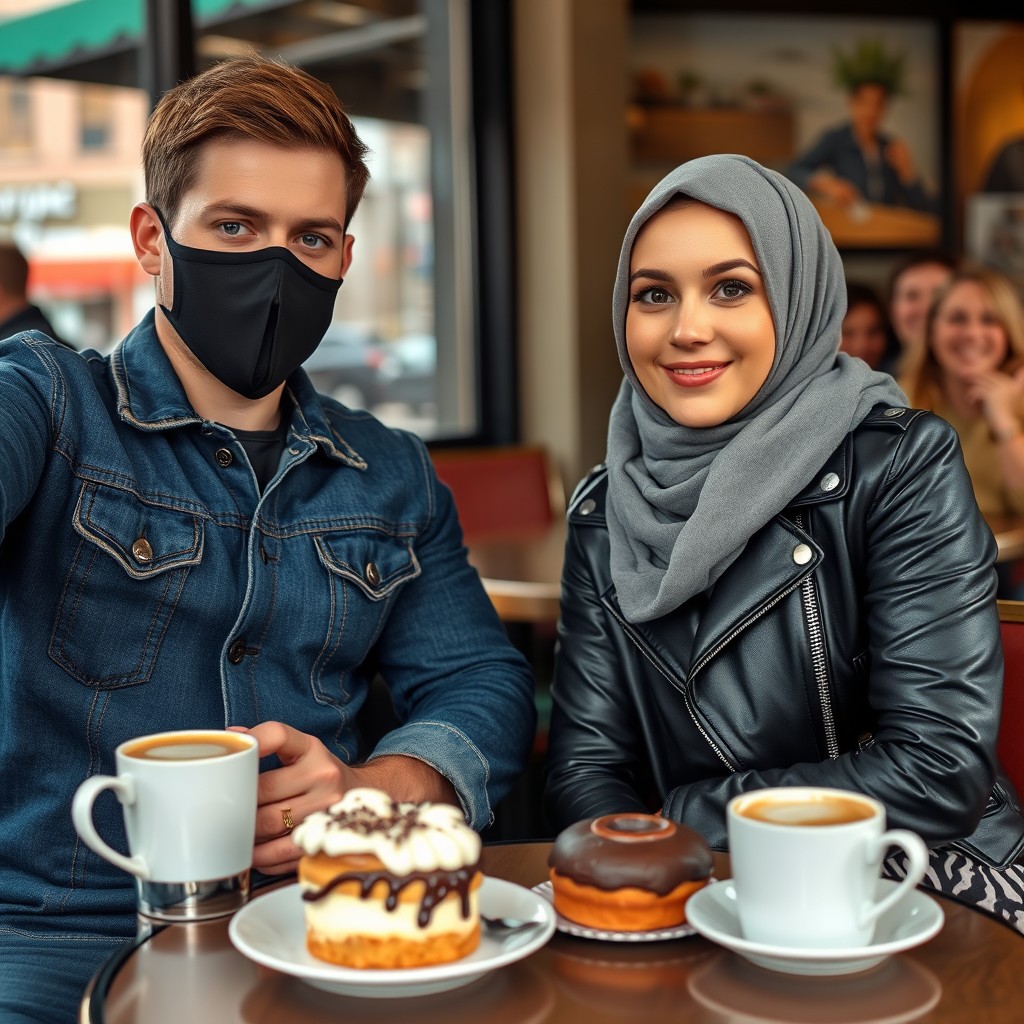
<box><xmin>81</xmin><ymin>843</ymin><xmax>1024</xmax><ymax>1024</ymax></box>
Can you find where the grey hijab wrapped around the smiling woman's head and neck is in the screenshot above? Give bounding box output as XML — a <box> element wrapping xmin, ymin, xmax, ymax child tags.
<box><xmin>607</xmin><ymin>155</ymin><xmax>907</xmax><ymax>622</ymax></box>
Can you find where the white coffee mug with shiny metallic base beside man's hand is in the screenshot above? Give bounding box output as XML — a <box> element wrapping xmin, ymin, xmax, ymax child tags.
<box><xmin>72</xmin><ymin>729</ymin><xmax>259</xmax><ymax>920</ymax></box>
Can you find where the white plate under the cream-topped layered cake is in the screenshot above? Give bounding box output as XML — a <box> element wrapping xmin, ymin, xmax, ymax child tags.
<box><xmin>227</xmin><ymin>878</ymin><xmax>555</xmax><ymax>998</ymax></box>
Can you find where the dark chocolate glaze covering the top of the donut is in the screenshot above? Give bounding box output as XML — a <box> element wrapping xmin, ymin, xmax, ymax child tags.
<box><xmin>548</xmin><ymin>813</ymin><xmax>712</xmax><ymax>896</ymax></box>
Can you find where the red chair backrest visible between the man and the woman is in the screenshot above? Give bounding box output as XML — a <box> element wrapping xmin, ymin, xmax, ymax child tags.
<box><xmin>430</xmin><ymin>444</ymin><xmax>565</xmax><ymax>543</ymax></box>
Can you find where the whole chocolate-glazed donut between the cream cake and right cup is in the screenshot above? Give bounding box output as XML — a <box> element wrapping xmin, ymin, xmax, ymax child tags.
<box><xmin>548</xmin><ymin>813</ymin><xmax>712</xmax><ymax>932</ymax></box>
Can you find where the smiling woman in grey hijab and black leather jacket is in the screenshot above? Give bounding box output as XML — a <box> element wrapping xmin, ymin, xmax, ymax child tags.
<box><xmin>547</xmin><ymin>156</ymin><xmax>1024</xmax><ymax>929</ymax></box>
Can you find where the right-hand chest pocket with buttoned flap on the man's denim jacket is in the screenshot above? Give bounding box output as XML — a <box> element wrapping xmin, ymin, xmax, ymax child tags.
<box><xmin>312</xmin><ymin>529</ymin><xmax>422</xmax><ymax>703</ymax></box>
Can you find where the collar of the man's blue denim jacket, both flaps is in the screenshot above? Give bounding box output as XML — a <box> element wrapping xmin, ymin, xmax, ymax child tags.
<box><xmin>111</xmin><ymin>309</ymin><xmax>367</xmax><ymax>469</ymax></box>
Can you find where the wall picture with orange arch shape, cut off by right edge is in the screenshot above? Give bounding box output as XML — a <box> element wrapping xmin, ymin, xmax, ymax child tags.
<box><xmin>953</xmin><ymin>22</ymin><xmax>1024</xmax><ymax>289</ymax></box>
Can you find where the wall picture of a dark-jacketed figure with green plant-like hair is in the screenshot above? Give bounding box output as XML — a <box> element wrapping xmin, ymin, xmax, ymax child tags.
<box><xmin>630</xmin><ymin>12</ymin><xmax>944</xmax><ymax>249</ymax></box>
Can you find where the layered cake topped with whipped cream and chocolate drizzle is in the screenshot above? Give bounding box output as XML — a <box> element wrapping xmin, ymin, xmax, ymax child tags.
<box><xmin>292</xmin><ymin>788</ymin><xmax>482</xmax><ymax>968</ymax></box>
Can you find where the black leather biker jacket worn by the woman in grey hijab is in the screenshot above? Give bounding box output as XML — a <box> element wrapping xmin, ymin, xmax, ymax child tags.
<box><xmin>546</xmin><ymin>407</ymin><xmax>1024</xmax><ymax>865</ymax></box>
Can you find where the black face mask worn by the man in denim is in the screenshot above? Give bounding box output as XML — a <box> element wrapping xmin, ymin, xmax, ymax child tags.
<box><xmin>157</xmin><ymin>210</ymin><xmax>341</xmax><ymax>398</ymax></box>
